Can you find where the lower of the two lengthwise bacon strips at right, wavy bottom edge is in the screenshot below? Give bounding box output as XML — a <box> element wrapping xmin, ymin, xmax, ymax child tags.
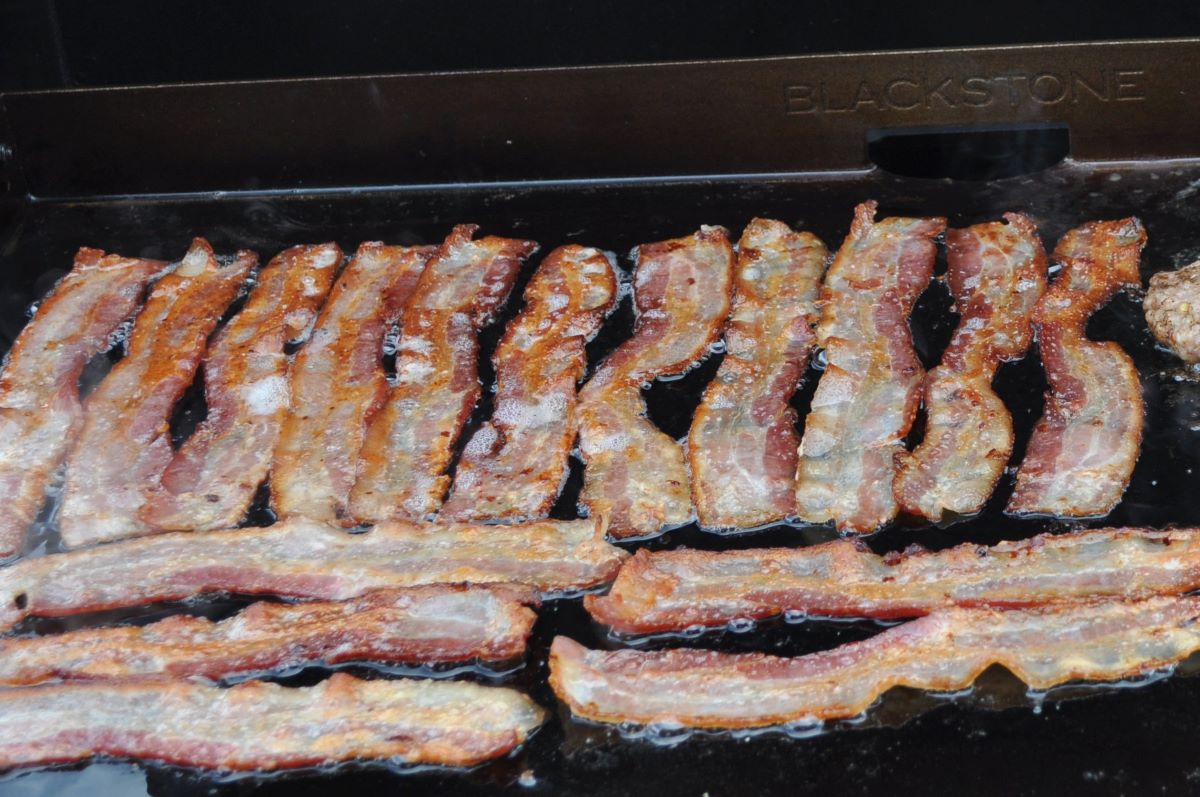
<box><xmin>550</xmin><ymin>598</ymin><xmax>1200</xmax><ymax>727</ymax></box>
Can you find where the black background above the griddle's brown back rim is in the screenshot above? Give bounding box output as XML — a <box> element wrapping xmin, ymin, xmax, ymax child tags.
<box><xmin>0</xmin><ymin>0</ymin><xmax>1200</xmax><ymax>91</ymax></box>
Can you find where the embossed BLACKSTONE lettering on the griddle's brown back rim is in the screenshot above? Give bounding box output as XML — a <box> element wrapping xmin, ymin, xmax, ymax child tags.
<box><xmin>784</xmin><ymin>68</ymin><xmax>1146</xmax><ymax>114</ymax></box>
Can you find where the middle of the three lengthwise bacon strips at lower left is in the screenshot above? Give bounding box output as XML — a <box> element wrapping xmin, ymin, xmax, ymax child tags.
<box><xmin>0</xmin><ymin>586</ymin><xmax>538</xmax><ymax>685</ymax></box>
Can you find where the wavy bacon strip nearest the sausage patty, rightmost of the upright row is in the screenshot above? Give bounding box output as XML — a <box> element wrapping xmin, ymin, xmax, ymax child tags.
<box><xmin>1007</xmin><ymin>218</ymin><xmax>1146</xmax><ymax>517</ymax></box>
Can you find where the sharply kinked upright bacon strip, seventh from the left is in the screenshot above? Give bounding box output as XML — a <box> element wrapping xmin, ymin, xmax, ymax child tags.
<box><xmin>578</xmin><ymin>227</ymin><xmax>733</xmax><ymax>538</ymax></box>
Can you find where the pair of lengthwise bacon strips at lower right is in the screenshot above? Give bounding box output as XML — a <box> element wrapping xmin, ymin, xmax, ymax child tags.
<box><xmin>550</xmin><ymin>528</ymin><xmax>1200</xmax><ymax>730</ymax></box>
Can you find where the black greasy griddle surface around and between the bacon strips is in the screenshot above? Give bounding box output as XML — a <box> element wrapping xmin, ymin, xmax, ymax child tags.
<box><xmin>0</xmin><ymin>162</ymin><xmax>1200</xmax><ymax>796</ymax></box>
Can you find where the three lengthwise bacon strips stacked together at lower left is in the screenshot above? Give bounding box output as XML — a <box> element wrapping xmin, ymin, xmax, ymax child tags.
<box><xmin>0</xmin><ymin>519</ymin><xmax>628</xmax><ymax>769</ymax></box>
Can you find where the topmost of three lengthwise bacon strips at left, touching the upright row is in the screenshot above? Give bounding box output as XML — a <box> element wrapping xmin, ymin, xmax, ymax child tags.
<box><xmin>0</xmin><ymin>519</ymin><xmax>629</xmax><ymax>628</ymax></box>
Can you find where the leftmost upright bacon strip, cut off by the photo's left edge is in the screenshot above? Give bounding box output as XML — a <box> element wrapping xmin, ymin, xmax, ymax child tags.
<box><xmin>0</xmin><ymin>248</ymin><xmax>167</xmax><ymax>558</ymax></box>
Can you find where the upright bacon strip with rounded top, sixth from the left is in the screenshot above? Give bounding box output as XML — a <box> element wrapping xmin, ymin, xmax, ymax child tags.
<box><xmin>438</xmin><ymin>244</ymin><xmax>617</xmax><ymax>521</ymax></box>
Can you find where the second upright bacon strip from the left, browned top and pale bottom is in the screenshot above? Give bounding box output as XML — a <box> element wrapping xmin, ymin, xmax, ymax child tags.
<box><xmin>59</xmin><ymin>238</ymin><xmax>258</xmax><ymax>547</ymax></box>
